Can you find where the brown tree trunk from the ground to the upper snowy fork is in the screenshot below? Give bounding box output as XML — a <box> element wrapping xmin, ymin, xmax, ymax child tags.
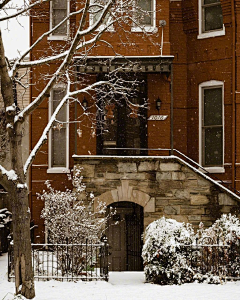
<box><xmin>9</xmin><ymin>123</ymin><xmax>35</xmax><ymax>299</ymax></box>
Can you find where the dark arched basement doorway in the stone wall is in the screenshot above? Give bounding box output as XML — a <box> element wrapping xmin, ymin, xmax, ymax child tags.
<box><xmin>107</xmin><ymin>201</ymin><xmax>143</xmax><ymax>271</ymax></box>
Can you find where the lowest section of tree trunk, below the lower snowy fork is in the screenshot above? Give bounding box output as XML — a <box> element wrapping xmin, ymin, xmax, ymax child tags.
<box><xmin>10</xmin><ymin>187</ymin><xmax>35</xmax><ymax>299</ymax></box>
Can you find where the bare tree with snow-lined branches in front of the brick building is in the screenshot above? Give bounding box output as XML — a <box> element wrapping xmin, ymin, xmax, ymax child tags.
<box><xmin>0</xmin><ymin>0</ymin><xmax>156</xmax><ymax>299</ymax></box>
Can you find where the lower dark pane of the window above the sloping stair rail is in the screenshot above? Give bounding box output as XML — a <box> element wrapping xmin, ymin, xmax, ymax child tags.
<box><xmin>203</xmin><ymin>127</ymin><xmax>223</xmax><ymax>166</ymax></box>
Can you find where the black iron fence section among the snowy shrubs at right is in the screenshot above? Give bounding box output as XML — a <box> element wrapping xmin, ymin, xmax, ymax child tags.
<box><xmin>181</xmin><ymin>237</ymin><xmax>240</xmax><ymax>279</ymax></box>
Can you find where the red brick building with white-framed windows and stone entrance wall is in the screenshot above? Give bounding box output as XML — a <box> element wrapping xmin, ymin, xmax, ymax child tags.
<box><xmin>30</xmin><ymin>0</ymin><xmax>240</xmax><ymax>270</ymax></box>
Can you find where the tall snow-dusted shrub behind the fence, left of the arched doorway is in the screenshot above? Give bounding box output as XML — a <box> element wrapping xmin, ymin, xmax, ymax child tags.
<box><xmin>38</xmin><ymin>168</ymin><xmax>108</xmax><ymax>274</ymax></box>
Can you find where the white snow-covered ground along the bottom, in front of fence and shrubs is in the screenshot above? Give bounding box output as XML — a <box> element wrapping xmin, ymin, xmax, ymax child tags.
<box><xmin>0</xmin><ymin>254</ymin><xmax>240</xmax><ymax>300</ymax></box>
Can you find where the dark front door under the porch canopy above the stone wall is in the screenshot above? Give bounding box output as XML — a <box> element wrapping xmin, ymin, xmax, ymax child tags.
<box><xmin>97</xmin><ymin>75</ymin><xmax>147</xmax><ymax>155</ymax></box>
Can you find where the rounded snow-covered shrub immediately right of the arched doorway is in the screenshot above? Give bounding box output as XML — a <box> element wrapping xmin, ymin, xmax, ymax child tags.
<box><xmin>142</xmin><ymin>217</ymin><xmax>194</xmax><ymax>284</ymax></box>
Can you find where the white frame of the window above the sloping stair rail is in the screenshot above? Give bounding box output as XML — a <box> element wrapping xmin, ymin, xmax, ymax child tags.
<box><xmin>199</xmin><ymin>80</ymin><xmax>225</xmax><ymax>173</ymax></box>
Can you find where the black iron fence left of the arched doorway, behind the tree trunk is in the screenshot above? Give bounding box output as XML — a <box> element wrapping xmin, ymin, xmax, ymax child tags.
<box><xmin>8</xmin><ymin>239</ymin><xmax>108</xmax><ymax>281</ymax></box>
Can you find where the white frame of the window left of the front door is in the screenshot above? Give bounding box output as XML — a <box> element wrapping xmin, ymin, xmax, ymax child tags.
<box><xmin>47</xmin><ymin>84</ymin><xmax>70</xmax><ymax>173</ymax></box>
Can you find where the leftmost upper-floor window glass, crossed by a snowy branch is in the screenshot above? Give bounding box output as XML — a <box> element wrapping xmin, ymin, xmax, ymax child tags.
<box><xmin>50</xmin><ymin>0</ymin><xmax>69</xmax><ymax>36</ymax></box>
